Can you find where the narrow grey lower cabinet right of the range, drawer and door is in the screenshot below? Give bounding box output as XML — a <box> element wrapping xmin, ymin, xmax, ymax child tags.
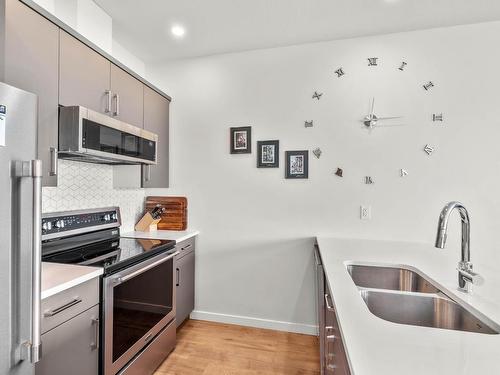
<box><xmin>175</xmin><ymin>238</ymin><xmax>195</xmax><ymax>327</ymax></box>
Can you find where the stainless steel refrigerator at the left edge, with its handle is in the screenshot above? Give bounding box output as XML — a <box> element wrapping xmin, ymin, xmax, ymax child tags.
<box><xmin>0</xmin><ymin>82</ymin><xmax>41</xmax><ymax>375</ymax></box>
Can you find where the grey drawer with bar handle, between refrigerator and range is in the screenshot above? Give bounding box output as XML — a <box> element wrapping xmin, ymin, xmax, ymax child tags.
<box><xmin>41</xmin><ymin>278</ymin><xmax>99</xmax><ymax>334</ymax></box>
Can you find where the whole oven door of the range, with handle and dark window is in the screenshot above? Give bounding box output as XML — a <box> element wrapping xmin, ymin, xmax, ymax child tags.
<box><xmin>103</xmin><ymin>253</ymin><xmax>176</xmax><ymax>375</ymax></box>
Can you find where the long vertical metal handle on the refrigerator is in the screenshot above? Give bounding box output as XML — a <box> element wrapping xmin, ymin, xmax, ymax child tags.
<box><xmin>15</xmin><ymin>160</ymin><xmax>43</xmax><ymax>363</ymax></box>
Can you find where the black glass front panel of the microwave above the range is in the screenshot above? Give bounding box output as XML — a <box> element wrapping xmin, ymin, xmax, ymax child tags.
<box><xmin>82</xmin><ymin>119</ymin><xmax>156</xmax><ymax>161</ymax></box>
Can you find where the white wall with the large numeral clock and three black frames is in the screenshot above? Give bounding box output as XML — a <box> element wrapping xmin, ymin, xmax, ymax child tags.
<box><xmin>148</xmin><ymin>23</ymin><xmax>500</xmax><ymax>331</ymax></box>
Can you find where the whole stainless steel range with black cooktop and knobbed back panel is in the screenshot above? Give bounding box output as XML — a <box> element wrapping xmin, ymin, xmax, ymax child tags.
<box><xmin>42</xmin><ymin>207</ymin><xmax>176</xmax><ymax>375</ymax></box>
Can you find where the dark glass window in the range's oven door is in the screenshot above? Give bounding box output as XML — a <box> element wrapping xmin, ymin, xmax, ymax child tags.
<box><xmin>113</xmin><ymin>259</ymin><xmax>173</xmax><ymax>362</ymax></box>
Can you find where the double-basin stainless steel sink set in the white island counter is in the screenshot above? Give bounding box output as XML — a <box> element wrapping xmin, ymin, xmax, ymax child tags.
<box><xmin>347</xmin><ymin>264</ymin><xmax>500</xmax><ymax>334</ymax></box>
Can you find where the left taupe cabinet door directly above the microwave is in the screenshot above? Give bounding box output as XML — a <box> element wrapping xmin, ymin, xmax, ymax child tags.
<box><xmin>59</xmin><ymin>30</ymin><xmax>112</xmax><ymax>114</ymax></box>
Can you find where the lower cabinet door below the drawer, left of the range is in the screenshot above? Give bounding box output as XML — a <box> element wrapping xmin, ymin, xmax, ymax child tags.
<box><xmin>35</xmin><ymin>305</ymin><xmax>99</xmax><ymax>375</ymax></box>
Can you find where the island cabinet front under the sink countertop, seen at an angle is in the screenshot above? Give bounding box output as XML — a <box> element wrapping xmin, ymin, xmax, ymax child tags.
<box><xmin>315</xmin><ymin>248</ymin><xmax>351</xmax><ymax>375</ymax></box>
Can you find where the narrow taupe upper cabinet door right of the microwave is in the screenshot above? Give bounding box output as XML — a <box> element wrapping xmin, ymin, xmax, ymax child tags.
<box><xmin>142</xmin><ymin>86</ymin><xmax>170</xmax><ymax>188</ymax></box>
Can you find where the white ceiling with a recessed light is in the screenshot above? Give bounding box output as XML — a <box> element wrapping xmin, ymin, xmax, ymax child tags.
<box><xmin>95</xmin><ymin>0</ymin><xmax>500</xmax><ymax>62</ymax></box>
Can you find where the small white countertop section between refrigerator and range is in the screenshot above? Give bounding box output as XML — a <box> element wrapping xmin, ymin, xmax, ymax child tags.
<box><xmin>42</xmin><ymin>262</ymin><xmax>103</xmax><ymax>300</ymax></box>
